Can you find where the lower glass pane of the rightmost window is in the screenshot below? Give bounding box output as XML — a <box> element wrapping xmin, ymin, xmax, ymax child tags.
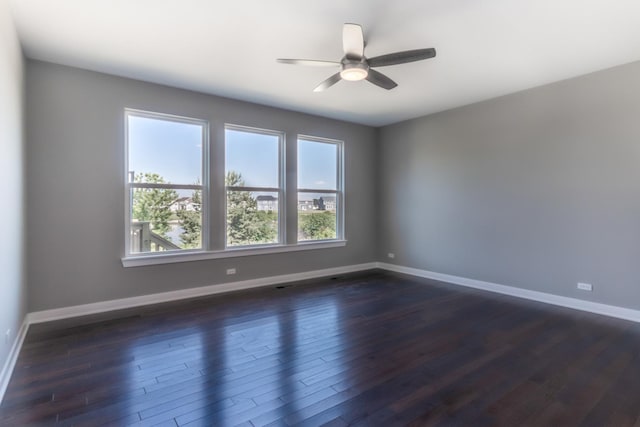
<box><xmin>298</xmin><ymin>193</ymin><xmax>337</xmax><ymax>241</ymax></box>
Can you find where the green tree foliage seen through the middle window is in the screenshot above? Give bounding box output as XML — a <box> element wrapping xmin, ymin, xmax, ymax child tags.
<box><xmin>225</xmin><ymin>171</ymin><xmax>278</xmax><ymax>246</ymax></box>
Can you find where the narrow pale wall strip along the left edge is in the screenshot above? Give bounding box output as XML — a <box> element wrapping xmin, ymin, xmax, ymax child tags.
<box><xmin>0</xmin><ymin>0</ymin><xmax>26</xmax><ymax>369</ymax></box>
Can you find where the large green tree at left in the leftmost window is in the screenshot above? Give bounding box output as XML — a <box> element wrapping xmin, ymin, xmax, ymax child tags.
<box><xmin>132</xmin><ymin>173</ymin><xmax>178</xmax><ymax>238</ymax></box>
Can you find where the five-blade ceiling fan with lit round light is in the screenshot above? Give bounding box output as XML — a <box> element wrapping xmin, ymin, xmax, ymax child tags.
<box><xmin>276</xmin><ymin>23</ymin><xmax>436</xmax><ymax>92</ymax></box>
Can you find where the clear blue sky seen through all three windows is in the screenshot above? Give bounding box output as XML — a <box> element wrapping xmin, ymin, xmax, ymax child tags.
<box><xmin>128</xmin><ymin>116</ymin><xmax>337</xmax><ymax>189</ymax></box>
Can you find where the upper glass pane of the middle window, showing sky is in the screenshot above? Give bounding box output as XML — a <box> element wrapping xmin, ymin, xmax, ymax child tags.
<box><xmin>225</xmin><ymin>129</ymin><xmax>280</xmax><ymax>188</ymax></box>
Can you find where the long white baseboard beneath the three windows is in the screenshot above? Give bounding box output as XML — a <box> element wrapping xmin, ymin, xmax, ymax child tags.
<box><xmin>27</xmin><ymin>262</ymin><xmax>376</xmax><ymax>324</ymax></box>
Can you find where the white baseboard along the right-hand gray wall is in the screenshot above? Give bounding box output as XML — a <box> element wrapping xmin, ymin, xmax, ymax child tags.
<box><xmin>377</xmin><ymin>262</ymin><xmax>640</xmax><ymax>323</ymax></box>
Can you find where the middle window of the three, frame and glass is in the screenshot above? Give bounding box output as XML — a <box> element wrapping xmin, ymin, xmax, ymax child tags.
<box><xmin>225</xmin><ymin>125</ymin><xmax>284</xmax><ymax>247</ymax></box>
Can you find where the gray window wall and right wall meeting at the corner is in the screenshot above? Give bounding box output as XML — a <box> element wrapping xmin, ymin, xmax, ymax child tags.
<box><xmin>25</xmin><ymin>55</ymin><xmax>640</xmax><ymax>311</ymax></box>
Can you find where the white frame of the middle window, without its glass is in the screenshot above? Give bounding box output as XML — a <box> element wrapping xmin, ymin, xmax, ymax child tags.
<box><xmin>224</xmin><ymin>123</ymin><xmax>287</xmax><ymax>251</ymax></box>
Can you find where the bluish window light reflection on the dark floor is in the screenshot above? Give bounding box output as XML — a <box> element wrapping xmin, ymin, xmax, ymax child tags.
<box><xmin>129</xmin><ymin>297</ymin><xmax>347</xmax><ymax>425</ymax></box>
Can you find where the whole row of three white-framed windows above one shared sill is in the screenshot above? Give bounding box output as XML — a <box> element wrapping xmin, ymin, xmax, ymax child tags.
<box><xmin>122</xmin><ymin>109</ymin><xmax>346</xmax><ymax>267</ymax></box>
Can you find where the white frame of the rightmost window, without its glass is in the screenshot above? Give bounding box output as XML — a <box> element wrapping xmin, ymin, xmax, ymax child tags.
<box><xmin>296</xmin><ymin>134</ymin><xmax>345</xmax><ymax>245</ymax></box>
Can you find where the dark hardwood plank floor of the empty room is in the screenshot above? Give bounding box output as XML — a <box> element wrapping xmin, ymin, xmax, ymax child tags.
<box><xmin>0</xmin><ymin>273</ymin><xmax>640</xmax><ymax>426</ymax></box>
